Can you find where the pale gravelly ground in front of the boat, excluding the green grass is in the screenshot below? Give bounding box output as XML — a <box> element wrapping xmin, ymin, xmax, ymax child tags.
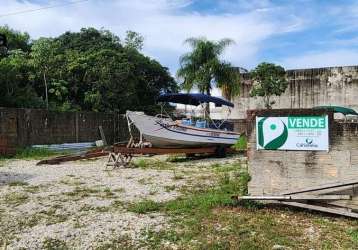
<box><xmin>0</xmin><ymin>157</ymin><xmax>241</xmax><ymax>249</ymax></box>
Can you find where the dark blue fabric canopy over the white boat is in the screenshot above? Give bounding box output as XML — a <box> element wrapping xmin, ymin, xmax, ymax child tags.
<box><xmin>157</xmin><ymin>93</ymin><xmax>234</xmax><ymax>107</ymax></box>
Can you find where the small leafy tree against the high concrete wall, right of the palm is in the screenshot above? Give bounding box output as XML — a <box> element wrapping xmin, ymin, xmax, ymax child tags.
<box><xmin>250</xmin><ymin>62</ymin><xmax>288</xmax><ymax>109</ymax></box>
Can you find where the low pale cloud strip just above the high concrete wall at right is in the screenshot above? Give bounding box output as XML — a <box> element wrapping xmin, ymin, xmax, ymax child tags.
<box><xmin>279</xmin><ymin>49</ymin><xmax>358</xmax><ymax>69</ymax></box>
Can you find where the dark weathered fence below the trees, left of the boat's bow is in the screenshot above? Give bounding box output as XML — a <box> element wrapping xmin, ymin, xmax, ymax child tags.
<box><xmin>0</xmin><ymin>108</ymin><xmax>128</xmax><ymax>154</ymax></box>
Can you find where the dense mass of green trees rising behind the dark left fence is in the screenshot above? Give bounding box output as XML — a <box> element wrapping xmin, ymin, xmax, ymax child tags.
<box><xmin>0</xmin><ymin>26</ymin><xmax>177</xmax><ymax>112</ymax></box>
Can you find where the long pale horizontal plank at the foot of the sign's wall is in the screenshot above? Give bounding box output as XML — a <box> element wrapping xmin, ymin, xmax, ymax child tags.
<box><xmin>237</xmin><ymin>195</ymin><xmax>351</xmax><ymax>201</ymax></box>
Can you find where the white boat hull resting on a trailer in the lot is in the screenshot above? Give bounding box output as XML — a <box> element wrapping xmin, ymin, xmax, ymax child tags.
<box><xmin>126</xmin><ymin>94</ymin><xmax>240</xmax><ymax>148</ymax></box>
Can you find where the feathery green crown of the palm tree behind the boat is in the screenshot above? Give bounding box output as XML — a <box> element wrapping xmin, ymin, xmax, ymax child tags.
<box><xmin>177</xmin><ymin>38</ymin><xmax>239</xmax><ymax>99</ymax></box>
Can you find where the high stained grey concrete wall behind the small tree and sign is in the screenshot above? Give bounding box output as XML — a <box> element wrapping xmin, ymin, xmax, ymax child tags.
<box><xmin>230</xmin><ymin>66</ymin><xmax>358</xmax><ymax>119</ymax></box>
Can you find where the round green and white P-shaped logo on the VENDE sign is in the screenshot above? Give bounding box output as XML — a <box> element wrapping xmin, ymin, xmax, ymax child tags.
<box><xmin>257</xmin><ymin>117</ymin><xmax>288</xmax><ymax>150</ymax></box>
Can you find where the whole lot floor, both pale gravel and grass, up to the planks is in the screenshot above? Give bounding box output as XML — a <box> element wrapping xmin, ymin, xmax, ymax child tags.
<box><xmin>0</xmin><ymin>156</ymin><xmax>358</xmax><ymax>249</ymax></box>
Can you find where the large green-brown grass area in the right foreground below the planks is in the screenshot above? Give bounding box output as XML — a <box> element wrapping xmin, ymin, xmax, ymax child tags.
<box><xmin>133</xmin><ymin>159</ymin><xmax>358</xmax><ymax>249</ymax></box>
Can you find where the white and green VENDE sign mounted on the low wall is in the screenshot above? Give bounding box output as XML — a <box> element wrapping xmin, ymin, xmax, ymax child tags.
<box><xmin>256</xmin><ymin>115</ymin><xmax>329</xmax><ymax>151</ymax></box>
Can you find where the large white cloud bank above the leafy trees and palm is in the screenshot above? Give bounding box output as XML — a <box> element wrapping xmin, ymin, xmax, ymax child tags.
<box><xmin>0</xmin><ymin>0</ymin><xmax>304</xmax><ymax>73</ymax></box>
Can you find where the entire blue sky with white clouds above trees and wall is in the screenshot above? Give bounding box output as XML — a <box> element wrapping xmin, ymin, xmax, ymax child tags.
<box><xmin>0</xmin><ymin>0</ymin><xmax>358</xmax><ymax>75</ymax></box>
